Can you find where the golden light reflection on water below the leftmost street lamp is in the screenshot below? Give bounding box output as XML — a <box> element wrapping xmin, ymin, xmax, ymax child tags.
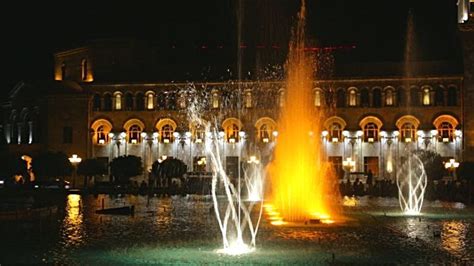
<box><xmin>62</xmin><ymin>194</ymin><xmax>84</xmax><ymax>247</ymax></box>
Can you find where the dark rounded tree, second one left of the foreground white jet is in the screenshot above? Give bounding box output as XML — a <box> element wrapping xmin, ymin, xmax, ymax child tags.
<box><xmin>110</xmin><ymin>155</ymin><xmax>143</xmax><ymax>184</ymax></box>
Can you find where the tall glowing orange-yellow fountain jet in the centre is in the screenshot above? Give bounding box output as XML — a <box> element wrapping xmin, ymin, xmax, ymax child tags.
<box><xmin>266</xmin><ymin>1</ymin><xmax>335</xmax><ymax>224</ymax></box>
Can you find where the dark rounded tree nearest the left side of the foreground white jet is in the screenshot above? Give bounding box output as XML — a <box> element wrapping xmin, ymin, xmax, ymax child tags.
<box><xmin>151</xmin><ymin>158</ymin><xmax>188</xmax><ymax>187</ymax></box>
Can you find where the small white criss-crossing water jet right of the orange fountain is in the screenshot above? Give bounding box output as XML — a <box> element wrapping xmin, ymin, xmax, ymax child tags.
<box><xmin>397</xmin><ymin>153</ymin><xmax>428</xmax><ymax>215</ymax></box>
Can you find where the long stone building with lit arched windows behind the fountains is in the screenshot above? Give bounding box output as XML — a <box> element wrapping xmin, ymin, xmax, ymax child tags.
<box><xmin>2</xmin><ymin>38</ymin><xmax>466</xmax><ymax>183</ymax></box>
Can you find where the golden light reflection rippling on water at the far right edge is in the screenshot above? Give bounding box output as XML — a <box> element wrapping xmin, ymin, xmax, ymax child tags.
<box><xmin>441</xmin><ymin>221</ymin><xmax>469</xmax><ymax>255</ymax></box>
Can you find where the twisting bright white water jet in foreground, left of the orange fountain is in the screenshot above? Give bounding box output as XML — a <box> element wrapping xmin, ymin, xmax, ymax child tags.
<box><xmin>188</xmin><ymin>84</ymin><xmax>263</xmax><ymax>255</ymax></box>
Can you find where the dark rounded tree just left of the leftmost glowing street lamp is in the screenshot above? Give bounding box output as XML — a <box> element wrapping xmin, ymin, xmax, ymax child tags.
<box><xmin>31</xmin><ymin>151</ymin><xmax>72</xmax><ymax>180</ymax></box>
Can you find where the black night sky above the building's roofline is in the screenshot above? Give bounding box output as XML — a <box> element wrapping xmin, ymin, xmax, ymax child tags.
<box><xmin>0</xmin><ymin>0</ymin><xmax>459</xmax><ymax>96</ymax></box>
